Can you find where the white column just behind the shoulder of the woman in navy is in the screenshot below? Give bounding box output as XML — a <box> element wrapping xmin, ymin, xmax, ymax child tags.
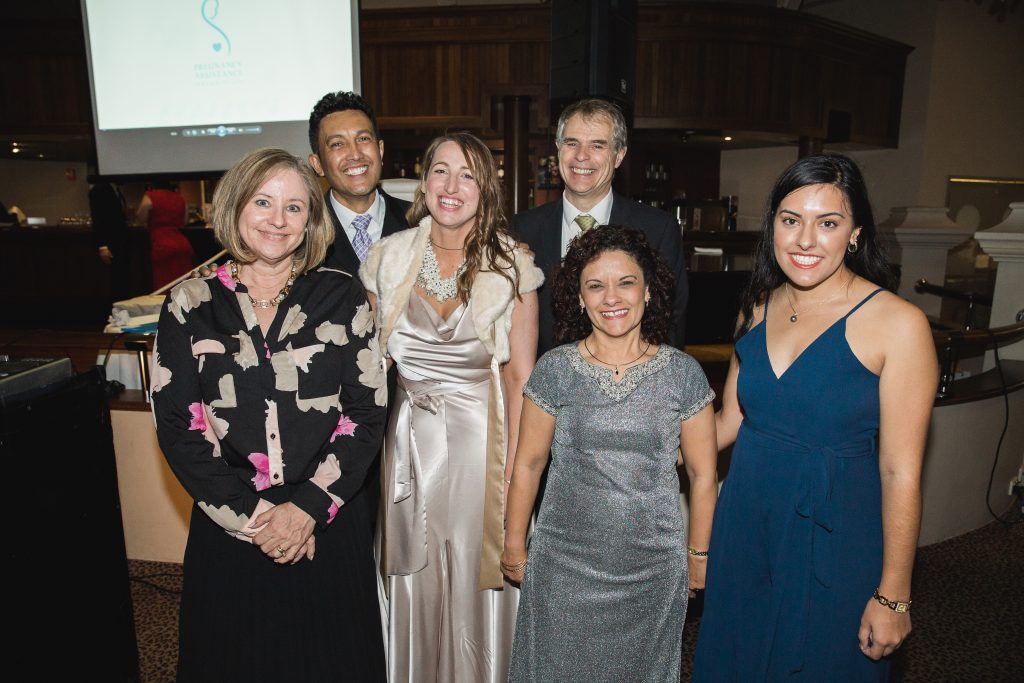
<box><xmin>879</xmin><ymin>207</ymin><xmax>972</xmax><ymax>317</ymax></box>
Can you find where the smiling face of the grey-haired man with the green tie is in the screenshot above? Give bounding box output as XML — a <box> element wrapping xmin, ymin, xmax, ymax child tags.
<box><xmin>558</xmin><ymin>114</ymin><xmax>626</xmax><ymax>211</ymax></box>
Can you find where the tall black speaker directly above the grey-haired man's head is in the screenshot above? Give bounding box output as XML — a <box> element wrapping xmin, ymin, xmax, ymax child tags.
<box><xmin>551</xmin><ymin>0</ymin><xmax>637</xmax><ymax>124</ymax></box>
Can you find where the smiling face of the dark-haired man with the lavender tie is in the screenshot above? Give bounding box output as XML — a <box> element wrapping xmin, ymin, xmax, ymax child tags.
<box><xmin>309</xmin><ymin>110</ymin><xmax>384</xmax><ymax>213</ymax></box>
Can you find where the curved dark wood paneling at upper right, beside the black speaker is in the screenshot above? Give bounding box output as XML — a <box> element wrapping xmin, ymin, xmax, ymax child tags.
<box><xmin>635</xmin><ymin>3</ymin><xmax>911</xmax><ymax>146</ymax></box>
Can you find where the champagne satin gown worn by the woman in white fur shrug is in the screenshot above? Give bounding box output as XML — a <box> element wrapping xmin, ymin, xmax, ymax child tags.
<box><xmin>382</xmin><ymin>292</ymin><xmax>519</xmax><ymax>683</ymax></box>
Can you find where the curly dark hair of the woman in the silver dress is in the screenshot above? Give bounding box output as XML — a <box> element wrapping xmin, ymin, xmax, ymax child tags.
<box><xmin>551</xmin><ymin>225</ymin><xmax>676</xmax><ymax>344</ymax></box>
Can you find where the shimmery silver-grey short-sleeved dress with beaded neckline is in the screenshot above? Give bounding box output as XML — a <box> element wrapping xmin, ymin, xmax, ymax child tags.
<box><xmin>509</xmin><ymin>344</ymin><xmax>715</xmax><ymax>683</ymax></box>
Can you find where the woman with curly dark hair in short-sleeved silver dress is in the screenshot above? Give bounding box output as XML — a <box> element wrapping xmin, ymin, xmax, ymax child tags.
<box><xmin>502</xmin><ymin>226</ymin><xmax>718</xmax><ymax>683</ymax></box>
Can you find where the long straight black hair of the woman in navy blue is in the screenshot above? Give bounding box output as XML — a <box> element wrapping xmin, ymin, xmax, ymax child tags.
<box><xmin>736</xmin><ymin>154</ymin><xmax>899</xmax><ymax>338</ymax></box>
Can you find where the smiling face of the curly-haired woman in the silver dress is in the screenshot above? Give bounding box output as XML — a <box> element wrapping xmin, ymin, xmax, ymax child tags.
<box><xmin>580</xmin><ymin>251</ymin><xmax>649</xmax><ymax>337</ymax></box>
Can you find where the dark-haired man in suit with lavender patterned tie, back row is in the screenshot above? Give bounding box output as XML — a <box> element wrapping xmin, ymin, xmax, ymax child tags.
<box><xmin>309</xmin><ymin>92</ymin><xmax>410</xmax><ymax>275</ymax></box>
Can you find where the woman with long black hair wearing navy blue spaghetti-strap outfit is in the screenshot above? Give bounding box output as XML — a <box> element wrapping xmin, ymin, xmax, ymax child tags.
<box><xmin>693</xmin><ymin>155</ymin><xmax>938</xmax><ymax>682</ymax></box>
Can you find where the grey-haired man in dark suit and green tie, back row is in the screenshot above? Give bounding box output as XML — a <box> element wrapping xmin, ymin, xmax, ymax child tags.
<box><xmin>512</xmin><ymin>98</ymin><xmax>687</xmax><ymax>355</ymax></box>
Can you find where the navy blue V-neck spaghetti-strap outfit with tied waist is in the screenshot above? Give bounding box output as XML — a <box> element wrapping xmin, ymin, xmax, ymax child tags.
<box><xmin>693</xmin><ymin>289</ymin><xmax>889</xmax><ymax>683</ymax></box>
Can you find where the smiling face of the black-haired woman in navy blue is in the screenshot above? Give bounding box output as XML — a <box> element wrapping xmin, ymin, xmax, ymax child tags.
<box><xmin>773</xmin><ymin>184</ymin><xmax>860</xmax><ymax>289</ymax></box>
